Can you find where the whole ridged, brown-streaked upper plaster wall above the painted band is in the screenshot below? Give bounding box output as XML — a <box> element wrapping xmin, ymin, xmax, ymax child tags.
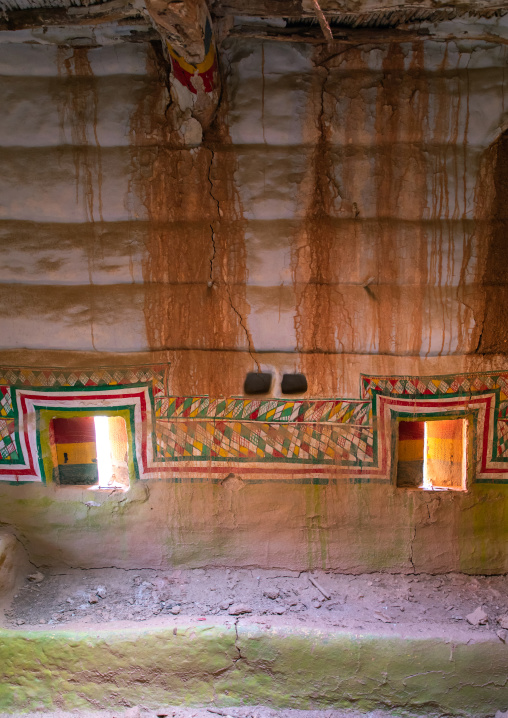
<box><xmin>0</xmin><ymin>33</ymin><xmax>506</xmax><ymax>360</ymax></box>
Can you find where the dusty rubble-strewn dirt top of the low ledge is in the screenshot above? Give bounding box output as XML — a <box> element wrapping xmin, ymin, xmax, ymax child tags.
<box><xmin>3</xmin><ymin>568</ymin><xmax>508</xmax><ymax>642</ymax></box>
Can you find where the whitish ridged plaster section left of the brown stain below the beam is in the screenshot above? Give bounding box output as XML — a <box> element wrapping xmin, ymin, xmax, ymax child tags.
<box><xmin>0</xmin><ymin>41</ymin><xmax>150</xmax><ymax>351</ymax></box>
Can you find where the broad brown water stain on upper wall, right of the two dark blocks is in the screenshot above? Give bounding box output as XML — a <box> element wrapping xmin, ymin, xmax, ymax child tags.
<box><xmin>292</xmin><ymin>41</ymin><xmax>473</xmax><ymax>382</ymax></box>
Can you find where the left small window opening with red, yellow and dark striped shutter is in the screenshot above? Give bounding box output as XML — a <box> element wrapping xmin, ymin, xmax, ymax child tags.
<box><xmin>51</xmin><ymin>416</ymin><xmax>129</xmax><ymax>488</ymax></box>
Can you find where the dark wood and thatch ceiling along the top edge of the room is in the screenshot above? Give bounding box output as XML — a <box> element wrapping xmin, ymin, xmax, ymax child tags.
<box><xmin>0</xmin><ymin>0</ymin><xmax>508</xmax><ymax>42</ymax></box>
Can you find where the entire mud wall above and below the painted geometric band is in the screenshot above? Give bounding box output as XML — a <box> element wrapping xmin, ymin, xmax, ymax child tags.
<box><xmin>0</xmin><ymin>33</ymin><xmax>508</xmax><ymax>572</ymax></box>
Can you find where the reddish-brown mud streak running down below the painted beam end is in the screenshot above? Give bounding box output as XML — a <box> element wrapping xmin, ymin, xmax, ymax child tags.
<box><xmin>131</xmin><ymin>45</ymin><xmax>251</xmax><ymax>394</ymax></box>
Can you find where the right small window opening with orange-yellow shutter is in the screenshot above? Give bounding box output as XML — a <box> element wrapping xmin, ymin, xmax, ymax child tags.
<box><xmin>397</xmin><ymin>419</ymin><xmax>468</xmax><ymax>491</ymax></box>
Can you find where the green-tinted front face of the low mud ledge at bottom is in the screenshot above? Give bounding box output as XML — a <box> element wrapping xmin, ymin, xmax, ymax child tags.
<box><xmin>0</xmin><ymin>619</ymin><xmax>508</xmax><ymax>718</ymax></box>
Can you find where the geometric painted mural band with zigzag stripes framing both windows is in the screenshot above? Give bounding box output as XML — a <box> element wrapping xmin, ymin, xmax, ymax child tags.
<box><xmin>0</xmin><ymin>364</ymin><xmax>508</xmax><ymax>483</ymax></box>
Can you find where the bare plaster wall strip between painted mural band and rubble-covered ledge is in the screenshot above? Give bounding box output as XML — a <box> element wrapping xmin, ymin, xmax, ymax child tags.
<box><xmin>0</xmin><ymin>480</ymin><xmax>508</xmax><ymax>573</ymax></box>
